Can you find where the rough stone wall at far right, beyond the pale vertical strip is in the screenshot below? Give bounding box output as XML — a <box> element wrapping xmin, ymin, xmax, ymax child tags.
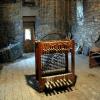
<box><xmin>84</xmin><ymin>0</ymin><xmax>100</xmax><ymax>47</ymax></box>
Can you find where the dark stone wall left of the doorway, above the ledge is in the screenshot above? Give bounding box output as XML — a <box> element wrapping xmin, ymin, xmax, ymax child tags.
<box><xmin>0</xmin><ymin>1</ymin><xmax>23</xmax><ymax>49</ymax></box>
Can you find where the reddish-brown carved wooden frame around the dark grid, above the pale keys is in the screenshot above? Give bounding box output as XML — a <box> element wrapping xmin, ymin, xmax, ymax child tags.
<box><xmin>35</xmin><ymin>40</ymin><xmax>76</xmax><ymax>92</ymax></box>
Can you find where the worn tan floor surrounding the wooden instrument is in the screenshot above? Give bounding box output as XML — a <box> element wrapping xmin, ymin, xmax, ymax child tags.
<box><xmin>0</xmin><ymin>54</ymin><xmax>100</xmax><ymax>100</ymax></box>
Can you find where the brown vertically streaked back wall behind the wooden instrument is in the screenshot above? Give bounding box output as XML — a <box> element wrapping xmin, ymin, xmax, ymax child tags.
<box><xmin>35</xmin><ymin>0</ymin><xmax>71</xmax><ymax>39</ymax></box>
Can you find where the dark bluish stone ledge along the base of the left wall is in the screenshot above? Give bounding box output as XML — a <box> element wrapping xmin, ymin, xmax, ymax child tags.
<box><xmin>0</xmin><ymin>42</ymin><xmax>22</xmax><ymax>63</ymax></box>
